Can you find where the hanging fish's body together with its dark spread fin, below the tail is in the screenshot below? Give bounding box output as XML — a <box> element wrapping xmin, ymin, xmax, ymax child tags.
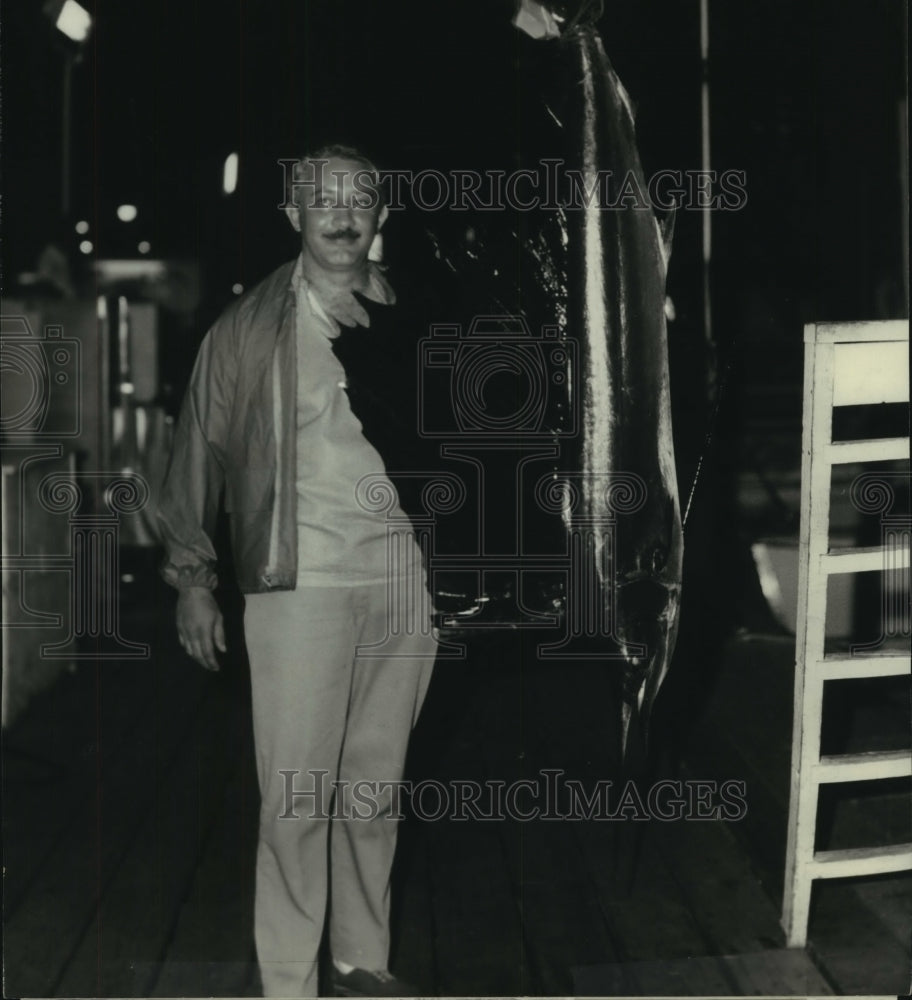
<box><xmin>334</xmin><ymin>16</ymin><xmax>683</xmax><ymax>751</ymax></box>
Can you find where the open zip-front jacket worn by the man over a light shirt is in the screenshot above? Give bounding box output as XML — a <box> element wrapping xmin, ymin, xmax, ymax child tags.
<box><xmin>158</xmin><ymin>261</ymin><xmax>298</xmax><ymax>593</ymax></box>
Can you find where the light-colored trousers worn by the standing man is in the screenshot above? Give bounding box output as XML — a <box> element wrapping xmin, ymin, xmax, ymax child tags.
<box><xmin>244</xmin><ymin>583</ymin><xmax>437</xmax><ymax>997</ymax></box>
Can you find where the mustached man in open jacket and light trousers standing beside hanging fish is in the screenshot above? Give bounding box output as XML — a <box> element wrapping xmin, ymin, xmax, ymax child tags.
<box><xmin>160</xmin><ymin>146</ymin><xmax>436</xmax><ymax>996</ymax></box>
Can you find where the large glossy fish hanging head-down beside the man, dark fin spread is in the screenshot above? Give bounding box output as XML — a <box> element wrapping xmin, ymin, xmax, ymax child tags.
<box><xmin>336</xmin><ymin>0</ymin><xmax>682</xmax><ymax>750</ymax></box>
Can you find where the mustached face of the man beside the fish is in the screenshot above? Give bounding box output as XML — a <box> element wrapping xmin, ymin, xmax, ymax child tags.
<box><xmin>286</xmin><ymin>157</ymin><xmax>387</xmax><ymax>272</ymax></box>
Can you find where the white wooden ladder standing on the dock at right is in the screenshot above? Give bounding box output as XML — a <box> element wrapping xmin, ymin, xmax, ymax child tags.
<box><xmin>782</xmin><ymin>320</ymin><xmax>912</xmax><ymax>948</ymax></box>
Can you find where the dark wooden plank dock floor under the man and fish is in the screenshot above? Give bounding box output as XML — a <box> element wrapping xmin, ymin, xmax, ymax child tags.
<box><xmin>3</xmin><ymin>595</ymin><xmax>912</xmax><ymax>997</ymax></box>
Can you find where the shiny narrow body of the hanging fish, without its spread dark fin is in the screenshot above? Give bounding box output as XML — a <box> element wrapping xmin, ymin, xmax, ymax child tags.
<box><xmin>564</xmin><ymin>25</ymin><xmax>683</xmax><ymax>746</ymax></box>
